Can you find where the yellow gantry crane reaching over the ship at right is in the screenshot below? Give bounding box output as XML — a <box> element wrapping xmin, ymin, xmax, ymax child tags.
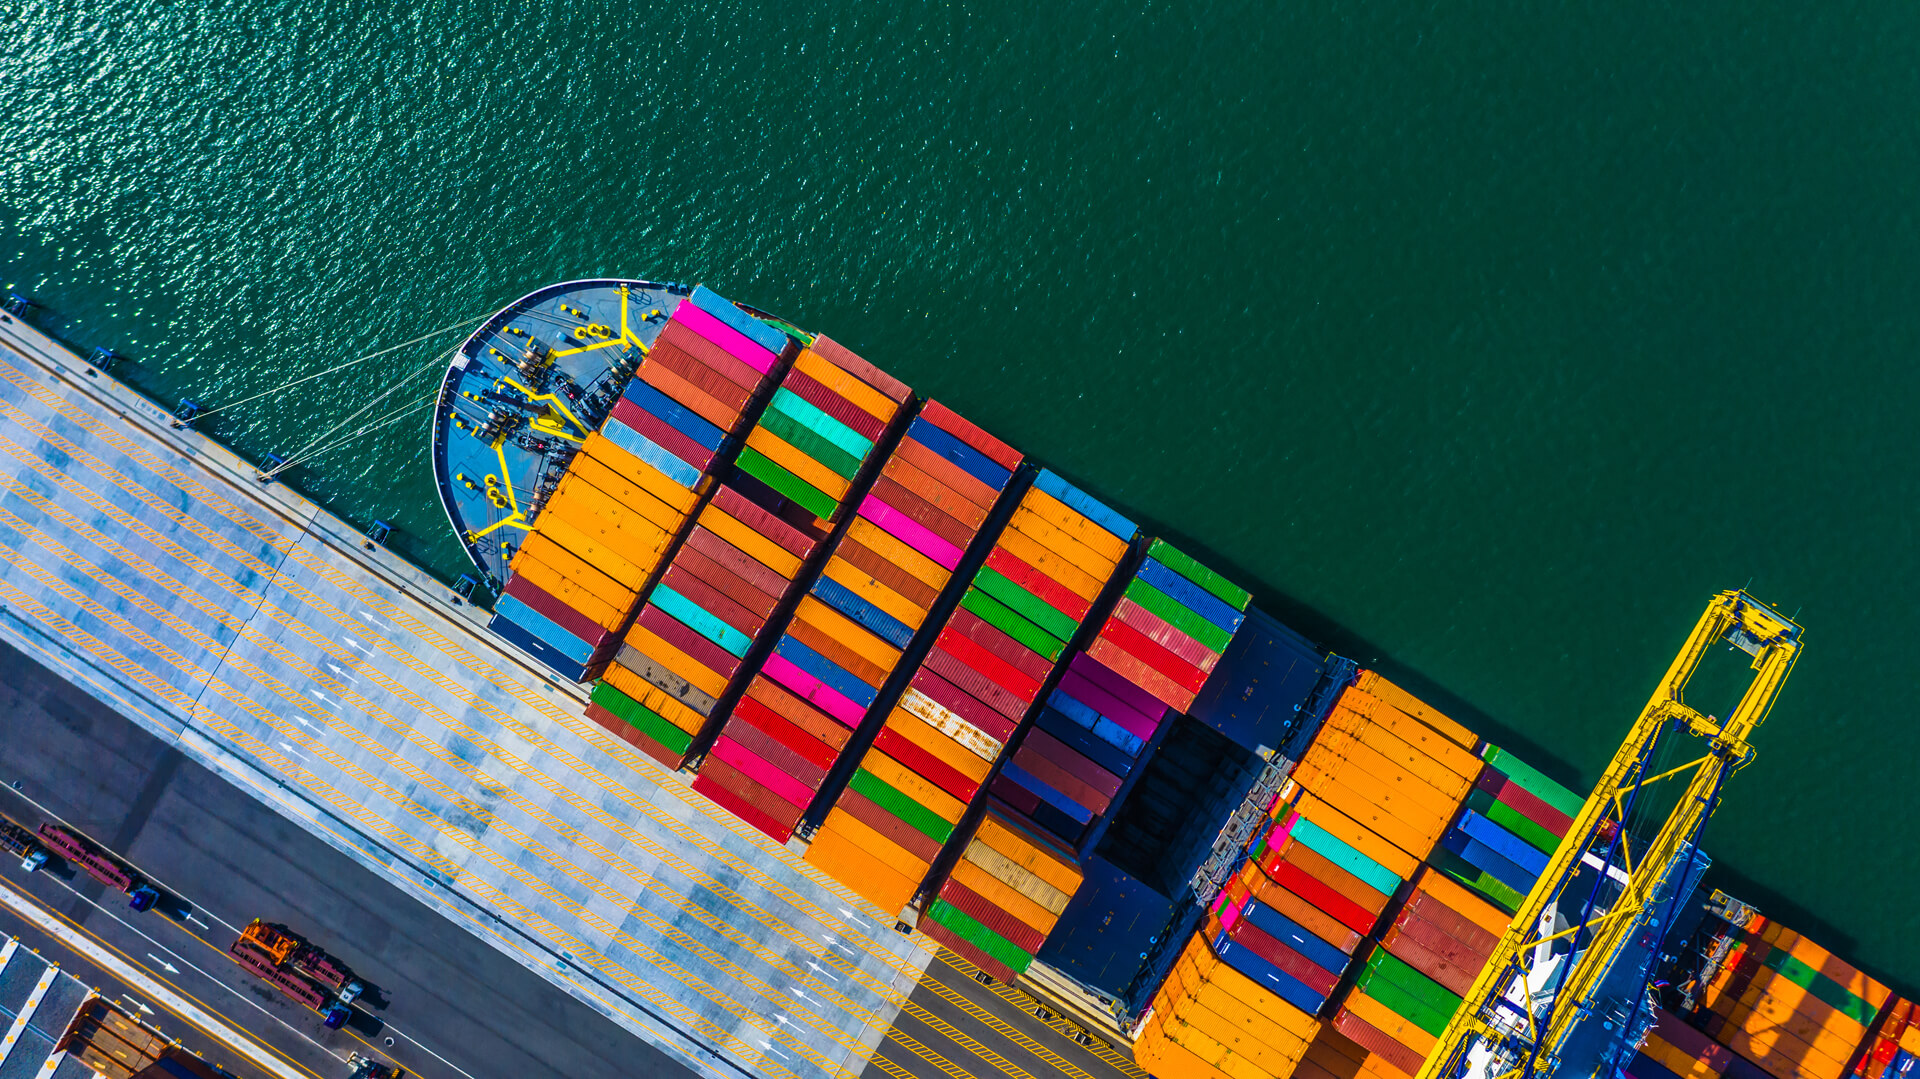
<box><xmin>1417</xmin><ymin>591</ymin><xmax>1801</xmax><ymax>1079</ymax></box>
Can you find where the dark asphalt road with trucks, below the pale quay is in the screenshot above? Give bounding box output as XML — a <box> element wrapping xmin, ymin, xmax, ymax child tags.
<box><xmin>0</xmin><ymin>645</ymin><xmax>691</xmax><ymax>1079</ymax></box>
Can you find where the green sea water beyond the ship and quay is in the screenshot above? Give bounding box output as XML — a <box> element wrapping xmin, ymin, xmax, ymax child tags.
<box><xmin>0</xmin><ymin>0</ymin><xmax>1920</xmax><ymax>989</ymax></box>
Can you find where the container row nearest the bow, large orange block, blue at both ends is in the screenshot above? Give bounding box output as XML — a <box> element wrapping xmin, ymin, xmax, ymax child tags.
<box><xmin>492</xmin><ymin>286</ymin><xmax>793</xmax><ymax>682</ymax></box>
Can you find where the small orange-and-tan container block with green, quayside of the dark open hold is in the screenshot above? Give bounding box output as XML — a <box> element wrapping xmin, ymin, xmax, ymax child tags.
<box><xmin>920</xmin><ymin>806</ymin><xmax>1083</xmax><ymax>981</ymax></box>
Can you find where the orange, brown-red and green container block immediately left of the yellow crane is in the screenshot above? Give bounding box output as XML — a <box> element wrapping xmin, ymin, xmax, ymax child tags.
<box><xmin>1332</xmin><ymin>866</ymin><xmax>1507</xmax><ymax>1075</ymax></box>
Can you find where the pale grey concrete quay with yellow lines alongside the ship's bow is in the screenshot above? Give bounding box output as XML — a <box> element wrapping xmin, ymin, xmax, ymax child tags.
<box><xmin>0</xmin><ymin>309</ymin><xmax>933</xmax><ymax>1079</ymax></box>
